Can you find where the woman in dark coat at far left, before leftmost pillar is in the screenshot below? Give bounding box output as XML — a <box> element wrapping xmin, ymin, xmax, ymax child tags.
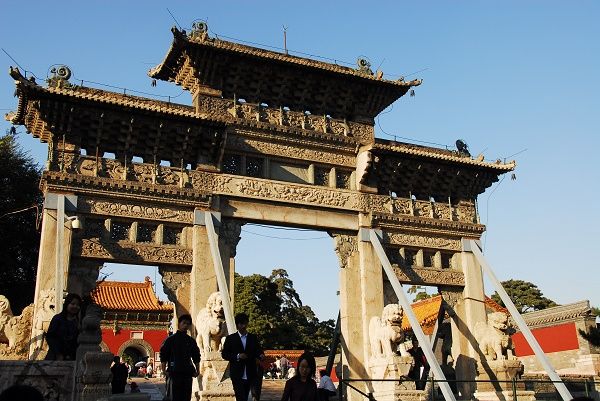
<box><xmin>46</xmin><ymin>294</ymin><xmax>81</xmax><ymax>361</ymax></box>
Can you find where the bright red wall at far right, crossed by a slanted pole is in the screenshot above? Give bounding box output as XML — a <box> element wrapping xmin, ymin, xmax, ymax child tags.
<box><xmin>512</xmin><ymin>323</ymin><xmax>579</xmax><ymax>356</ymax></box>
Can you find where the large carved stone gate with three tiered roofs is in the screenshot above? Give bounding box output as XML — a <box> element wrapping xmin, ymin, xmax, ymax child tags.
<box><xmin>7</xmin><ymin>25</ymin><xmax>515</xmax><ymax>400</ymax></box>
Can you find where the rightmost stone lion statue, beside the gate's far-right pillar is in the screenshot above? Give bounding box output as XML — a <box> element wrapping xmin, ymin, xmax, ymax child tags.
<box><xmin>474</xmin><ymin>312</ymin><xmax>516</xmax><ymax>361</ymax></box>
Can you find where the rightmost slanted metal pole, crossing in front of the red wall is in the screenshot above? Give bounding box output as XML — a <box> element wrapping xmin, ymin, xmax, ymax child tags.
<box><xmin>463</xmin><ymin>240</ymin><xmax>573</xmax><ymax>401</ymax></box>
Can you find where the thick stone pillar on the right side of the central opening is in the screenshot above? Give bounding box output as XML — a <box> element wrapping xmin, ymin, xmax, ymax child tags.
<box><xmin>335</xmin><ymin>227</ymin><xmax>383</xmax><ymax>399</ymax></box>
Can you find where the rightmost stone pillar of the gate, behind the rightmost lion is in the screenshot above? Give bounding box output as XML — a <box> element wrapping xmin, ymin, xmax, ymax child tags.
<box><xmin>452</xmin><ymin>247</ymin><xmax>487</xmax><ymax>398</ymax></box>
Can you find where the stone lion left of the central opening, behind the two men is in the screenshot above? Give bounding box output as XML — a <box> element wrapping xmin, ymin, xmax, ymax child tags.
<box><xmin>196</xmin><ymin>292</ymin><xmax>227</xmax><ymax>354</ymax></box>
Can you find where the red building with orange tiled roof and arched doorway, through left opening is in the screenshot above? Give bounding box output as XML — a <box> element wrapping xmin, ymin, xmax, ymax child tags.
<box><xmin>92</xmin><ymin>277</ymin><xmax>173</xmax><ymax>363</ymax></box>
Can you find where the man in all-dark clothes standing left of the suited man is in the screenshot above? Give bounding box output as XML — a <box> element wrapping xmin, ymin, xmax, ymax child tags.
<box><xmin>160</xmin><ymin>315</ymin><xmax>200</xmax><ymax>401</ymax></box>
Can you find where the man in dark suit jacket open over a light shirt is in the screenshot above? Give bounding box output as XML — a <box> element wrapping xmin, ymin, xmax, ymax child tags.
<box><xmin>221</xmin><ymin>313</ymin><xmax>264</xmax><ymax>401</ymax></box>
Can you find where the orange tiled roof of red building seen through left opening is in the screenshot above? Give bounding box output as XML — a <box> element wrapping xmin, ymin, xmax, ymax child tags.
<box><xmin>92</xmin><ymin>277</ymin><xmax>173</xmax><ymax>312</ymax></box>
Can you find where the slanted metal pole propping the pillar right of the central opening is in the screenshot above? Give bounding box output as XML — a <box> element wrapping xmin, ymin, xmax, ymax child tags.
<box><xmin>368</xmin><ymin>229</ymin><xmax>456</xmax><ymax>401</ymax></box>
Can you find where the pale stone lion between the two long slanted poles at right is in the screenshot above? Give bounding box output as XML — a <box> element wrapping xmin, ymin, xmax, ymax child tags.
<box><xmin>369</xmin><ymin>304</ymin><xmax>404</xmax><ymax>358</ymax></box>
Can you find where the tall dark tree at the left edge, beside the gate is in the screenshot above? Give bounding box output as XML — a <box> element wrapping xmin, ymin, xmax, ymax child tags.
<box><xmin>0</xmin><ymin>131</ymin><xmax>43</xmax><ymax>314</ymax></box>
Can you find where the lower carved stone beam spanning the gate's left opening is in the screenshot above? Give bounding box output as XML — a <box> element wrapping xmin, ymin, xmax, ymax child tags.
<box><xmin>74</xmin><ymin>238</ymin><xmax>192</xmax><ymax>265</ymax></box>
